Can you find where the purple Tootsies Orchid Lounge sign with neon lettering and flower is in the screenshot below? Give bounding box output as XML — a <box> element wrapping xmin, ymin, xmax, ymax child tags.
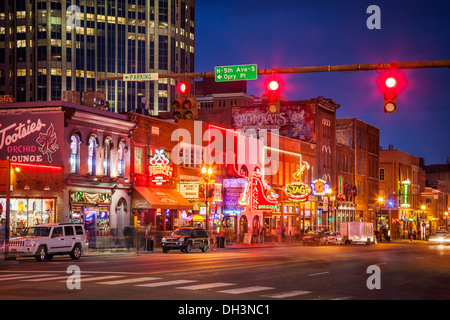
<box><xmin>0</xmin><ymin>112</ymin><xmax>64</xmax><ymax>166</ymax></box>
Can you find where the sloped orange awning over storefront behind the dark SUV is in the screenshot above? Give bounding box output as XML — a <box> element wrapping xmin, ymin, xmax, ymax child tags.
<box><xmin>131</xmin><ymin>187</ymin><xmax>192</xmax><ymax>209</ymax></box>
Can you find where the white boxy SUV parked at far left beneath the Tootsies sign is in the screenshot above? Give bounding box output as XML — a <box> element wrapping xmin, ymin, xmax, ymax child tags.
<box><xmin>3</xmin><ymin>223</ymin><xmax>88</xmax><ymax>261</ymax></box>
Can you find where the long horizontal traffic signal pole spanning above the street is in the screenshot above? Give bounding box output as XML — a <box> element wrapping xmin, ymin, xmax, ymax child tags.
<box><xmin>98</xmin><ymin>60</ymin><xmax>450</xmax><ymax>81</ymax></box>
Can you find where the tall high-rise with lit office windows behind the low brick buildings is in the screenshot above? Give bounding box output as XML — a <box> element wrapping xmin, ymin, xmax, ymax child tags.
<box><xmin>0</xmin><ymin>0</ymin><xmax>195</xmax><ymax>115</ymax></box>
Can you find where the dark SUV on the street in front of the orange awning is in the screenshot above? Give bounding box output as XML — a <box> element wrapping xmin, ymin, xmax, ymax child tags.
<box><xmin>161</xmin><ymin>228</ymin><xmax>209</xmax><ymax>253</ymax></box>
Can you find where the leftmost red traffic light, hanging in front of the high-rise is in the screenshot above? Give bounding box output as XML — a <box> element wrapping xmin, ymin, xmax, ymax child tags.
<box><xmin>172</xmin><ymin>81</ymin><xmax>198</xmax><ymax>121</ymax></box>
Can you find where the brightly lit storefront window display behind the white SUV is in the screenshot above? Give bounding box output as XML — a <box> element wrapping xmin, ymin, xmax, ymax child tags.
<box><xmin>0</xmin><ymin>198</ymin><xmax>56</xmax><ymax>237</ymax></box>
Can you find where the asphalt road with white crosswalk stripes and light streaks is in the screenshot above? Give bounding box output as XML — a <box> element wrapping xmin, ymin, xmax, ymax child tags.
<box><xmin>0</xmin><ymin>242</ymin><xmax>450</xmax><ymax>302</ymax></box>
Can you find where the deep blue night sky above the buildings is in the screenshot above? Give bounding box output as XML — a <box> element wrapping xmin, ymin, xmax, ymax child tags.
<box><xmin>195</xmin><ymin>0</ymin><xmax>450</xmax><ymax>165</ymax></box>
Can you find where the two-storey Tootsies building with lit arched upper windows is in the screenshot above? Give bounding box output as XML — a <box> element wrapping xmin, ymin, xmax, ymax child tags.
<box><xmin>0</xmin><ymin>101</ymin><xmax>135</xmax><ymax>247</ymax></box>
